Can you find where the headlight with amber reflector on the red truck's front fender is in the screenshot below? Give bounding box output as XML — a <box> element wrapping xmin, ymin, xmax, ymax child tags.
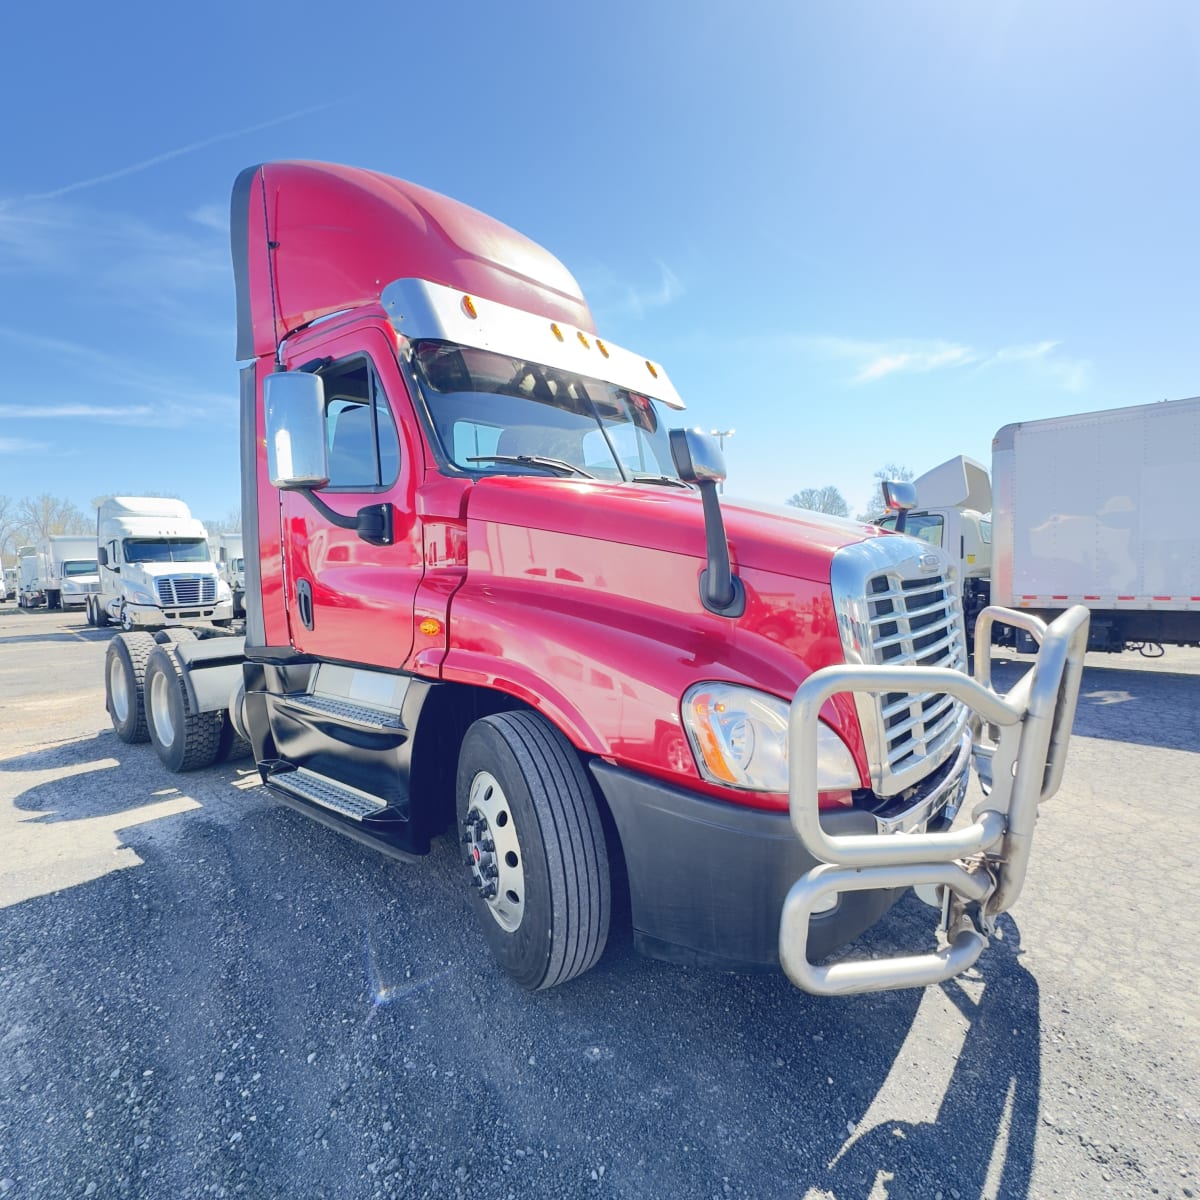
<box><xmin>683</xmin><ymin>683</ymin><xmax>860</xmax><ymax>792</ymax></box>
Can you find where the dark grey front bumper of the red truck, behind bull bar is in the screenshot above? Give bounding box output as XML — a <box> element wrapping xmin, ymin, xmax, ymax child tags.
<box><xmin>592</xmin><ymin>739</ymin><xmax>971</xmax><ymax>968</ymax></box>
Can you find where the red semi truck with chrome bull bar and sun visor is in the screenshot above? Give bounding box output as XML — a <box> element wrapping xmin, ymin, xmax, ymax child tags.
<box><xmin>106</xmin><ymin>162</ymin><xmax>1086</xmax><ymax>992</ymax></box>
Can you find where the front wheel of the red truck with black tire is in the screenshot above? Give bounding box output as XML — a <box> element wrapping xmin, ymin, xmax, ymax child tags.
<box><xmin>457</xmin><ymin>713</ymin><xmax>612</xmax><ymax>991</ymax></box>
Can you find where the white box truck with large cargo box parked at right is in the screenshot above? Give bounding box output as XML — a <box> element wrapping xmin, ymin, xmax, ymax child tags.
<box><xmin>902</xmin><ymin>397</ymin><xmax>1200</xmax><ymax>653</ymax></box>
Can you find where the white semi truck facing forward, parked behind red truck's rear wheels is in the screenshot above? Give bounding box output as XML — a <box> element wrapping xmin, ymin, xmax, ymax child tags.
<box><xmin>88</xmin><ymin>496</ymin><xmax>233</xmax><ymax>630</ymax></box>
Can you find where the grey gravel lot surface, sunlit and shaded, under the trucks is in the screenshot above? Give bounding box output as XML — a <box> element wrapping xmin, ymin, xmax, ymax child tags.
<box><xmin>0</xmin><ymin>601</ymin><xmax>1200</xmax><ymax>1200</ymax></box>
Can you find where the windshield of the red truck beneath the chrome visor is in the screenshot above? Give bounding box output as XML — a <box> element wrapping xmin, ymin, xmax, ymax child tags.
<box><xmin>412</xmin><ymin>340</ymin><xmax>682</xmax><ymax>486</ymax></box>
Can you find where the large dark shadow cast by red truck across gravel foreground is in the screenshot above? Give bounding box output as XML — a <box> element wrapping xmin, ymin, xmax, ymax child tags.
<box><xmin>0</xmin><ymin>736</ymin><xmax>1040</xmax><ymax>1200</ymax></box>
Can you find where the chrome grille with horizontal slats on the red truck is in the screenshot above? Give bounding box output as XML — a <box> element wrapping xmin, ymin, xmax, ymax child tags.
<box><xmin>833</xmin><ymin>538</ymin><xmax>967</xmax><ymax>796</ymax></box>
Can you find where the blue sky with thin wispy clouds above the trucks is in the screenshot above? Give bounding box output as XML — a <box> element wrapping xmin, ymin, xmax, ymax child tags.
<box><xmin>0</xmin><ymin>0</ymin><xmax>1200</xmax><ymax>530</ymax></box>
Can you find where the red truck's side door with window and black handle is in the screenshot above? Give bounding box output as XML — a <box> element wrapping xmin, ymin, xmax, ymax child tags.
<box><xmin>281</xmin><ymin>329</ymin><xmax>424</xmax><ymax>668</ymax></box>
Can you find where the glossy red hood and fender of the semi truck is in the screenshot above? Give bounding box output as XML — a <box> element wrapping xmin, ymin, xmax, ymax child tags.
<box><xmin>442</xmin><ymin>475</ymin><xmax>888</xmax><ymax>792</ymax></box>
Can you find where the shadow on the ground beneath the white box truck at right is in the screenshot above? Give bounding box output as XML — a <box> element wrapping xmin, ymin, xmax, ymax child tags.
<box><xmin>992</xmin><ymin>660</ymin><xmax>1200</xmax><ymax>750</ymax></box>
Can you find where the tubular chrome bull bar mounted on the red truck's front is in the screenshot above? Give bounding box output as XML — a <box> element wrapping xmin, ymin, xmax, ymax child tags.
<box><xmin>779</xmin><ymin>605</ymin><xmax>1090</xmax><ymax>996</ymax></box>
